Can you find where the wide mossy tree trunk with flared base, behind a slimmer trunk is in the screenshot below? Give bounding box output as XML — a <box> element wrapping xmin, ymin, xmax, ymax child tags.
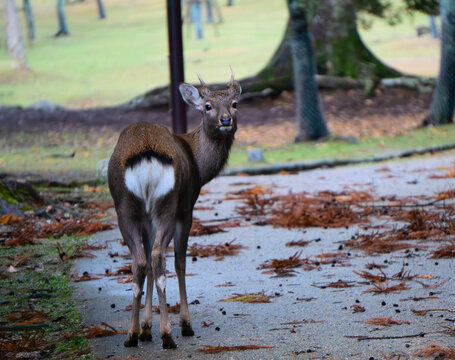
<box><xmin>248</xmin><ymin>0</ymin><xmax>439</xmax><ymax>95</ymax></box>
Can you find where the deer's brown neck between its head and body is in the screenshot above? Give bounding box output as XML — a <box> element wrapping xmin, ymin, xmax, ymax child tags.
<box><xmin>185</xmin><ymin>124</ymin><xmax>234</xmax><ymax>186</ymax></box>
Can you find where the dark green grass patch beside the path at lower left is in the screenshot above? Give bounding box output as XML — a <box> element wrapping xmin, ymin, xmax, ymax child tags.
<box><xmin>0</xmin><ymin>237</ymin><xmax>91</xmax><ymax>360</ymax></box>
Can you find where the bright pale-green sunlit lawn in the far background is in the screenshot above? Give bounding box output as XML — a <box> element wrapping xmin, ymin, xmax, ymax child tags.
<box><xmin>0</xmin><ymin>0</ymin><xmax>439</xmax><ymax>108</ymax></box>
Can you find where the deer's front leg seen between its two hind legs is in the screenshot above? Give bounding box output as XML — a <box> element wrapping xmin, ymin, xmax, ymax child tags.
<box><xmin>139</xmin><ymin>218</ymin><xmax>155</xmax><ymax>341</ymax></box>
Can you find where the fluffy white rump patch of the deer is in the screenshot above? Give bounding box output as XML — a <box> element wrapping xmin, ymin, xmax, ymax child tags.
<box><xmin>125</xmin><ymin>157</ymin><xmax>175</xmax><ymax>213</ymax></box>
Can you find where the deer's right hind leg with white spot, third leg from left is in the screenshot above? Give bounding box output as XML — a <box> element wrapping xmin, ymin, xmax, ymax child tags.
<box><xmin>152</xmin><ymin>226</ymin><xmax>177</xmax><ymax>349</ymax></box>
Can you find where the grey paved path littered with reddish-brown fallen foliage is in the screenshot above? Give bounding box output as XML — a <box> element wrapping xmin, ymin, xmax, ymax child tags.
<box><xmin>75</xmin><ymin>153</ymin><xmax>455</xmax><ymax>359</ymax></box>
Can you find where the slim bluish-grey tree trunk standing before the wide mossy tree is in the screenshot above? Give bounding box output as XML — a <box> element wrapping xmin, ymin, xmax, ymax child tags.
<box><xmin>288</xmin><ymin>0</ymin><xmax>329</xmax><ymax>142</ymax></box>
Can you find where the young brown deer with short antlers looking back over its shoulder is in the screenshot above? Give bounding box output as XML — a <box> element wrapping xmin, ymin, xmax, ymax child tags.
<box><xmin>108</xmin><ymin>69</ymin><xmax>241</xmax><ymax>349</ymax></box>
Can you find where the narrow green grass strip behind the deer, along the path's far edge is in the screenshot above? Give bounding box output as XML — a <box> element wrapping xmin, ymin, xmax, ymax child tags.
<box><xmin>0</xmin><ymin>124</ymin><xmax>455</xmax><ymax>182</ymax></box>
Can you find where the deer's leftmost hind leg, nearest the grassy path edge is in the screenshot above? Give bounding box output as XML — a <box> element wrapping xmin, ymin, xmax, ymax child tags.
<box><xmin>117</xmin><ymin>203</ymin><xmax>147</xmax><ymax>347</ymax></box>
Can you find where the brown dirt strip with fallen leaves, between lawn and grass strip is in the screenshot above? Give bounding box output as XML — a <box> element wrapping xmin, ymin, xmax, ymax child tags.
<box><xmin>0</xmin><ymin>89</ymin><xmax>431</xmax><ymax>145</ymax></box>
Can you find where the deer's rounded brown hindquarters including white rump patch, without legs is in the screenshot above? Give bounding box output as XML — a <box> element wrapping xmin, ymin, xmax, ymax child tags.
<box><xmin>108</xmin><ymin>123</ymin><xmax>199</xmax><ymax>215</ymax></box>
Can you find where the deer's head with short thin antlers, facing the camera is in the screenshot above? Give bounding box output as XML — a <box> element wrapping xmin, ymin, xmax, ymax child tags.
<box><xmin>179</xmin><ymin>68</ymin><xmax>242</xmax><ymax>138</ymax></box>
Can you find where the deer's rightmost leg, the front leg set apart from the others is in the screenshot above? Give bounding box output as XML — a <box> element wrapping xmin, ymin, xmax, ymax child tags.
<box><xmin>174</xmin><ymin>215</ymin><xmax>194</xmax><ymax>336</ymax></box>
